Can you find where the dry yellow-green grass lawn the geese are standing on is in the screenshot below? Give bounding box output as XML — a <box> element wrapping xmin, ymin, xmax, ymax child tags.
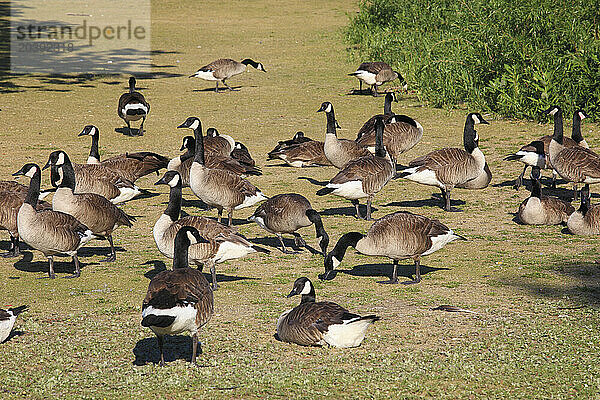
<box><xmin>0</xmin><ymin>0</ymin><xmax>600</xmax><ymax>399</ymax></box>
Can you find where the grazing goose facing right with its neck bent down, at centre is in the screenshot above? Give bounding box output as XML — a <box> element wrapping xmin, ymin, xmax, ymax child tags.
<box><xmin>248</xmin><ymin>193</ymin><xmax>329</xmax><ymax>256</ymax></box>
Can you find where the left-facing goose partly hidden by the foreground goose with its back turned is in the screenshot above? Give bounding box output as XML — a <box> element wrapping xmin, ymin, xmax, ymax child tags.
<box><xmin>152</xmin><ymin>171</ymin><xmax>269</xmax><ymax>290</ymax></box>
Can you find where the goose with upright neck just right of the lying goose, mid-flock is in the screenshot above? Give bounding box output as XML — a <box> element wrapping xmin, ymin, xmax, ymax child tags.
<box><xmin>317</xmin><ymin>101</ymin><xmax>371</xmax><ymax>169</ymax></box>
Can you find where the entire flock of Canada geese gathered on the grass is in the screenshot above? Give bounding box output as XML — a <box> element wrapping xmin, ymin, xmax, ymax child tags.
<box><xmin>0</xmin><ymin>59</ymin><xmax>600</xmax><ymax>365</ymax></box>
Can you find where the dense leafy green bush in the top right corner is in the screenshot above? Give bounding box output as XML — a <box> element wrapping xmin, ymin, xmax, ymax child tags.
<box><xmin>346</xmin><ymin>0</ymin><xmax>600</xmax><ymax>119</ymax></box>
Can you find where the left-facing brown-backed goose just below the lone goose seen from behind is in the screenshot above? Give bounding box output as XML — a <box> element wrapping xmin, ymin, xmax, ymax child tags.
<box><xmin>78</xmin><ymin>125</ymin><xmax>169</xmax><ymax>182</ymax></box>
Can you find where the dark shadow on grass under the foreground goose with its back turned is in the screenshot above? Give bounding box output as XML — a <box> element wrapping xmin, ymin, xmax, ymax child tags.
<box><xmin>133</xmin><ymin>336</ymin><xmax>202</xmax><ymax>366</ymax></box>
